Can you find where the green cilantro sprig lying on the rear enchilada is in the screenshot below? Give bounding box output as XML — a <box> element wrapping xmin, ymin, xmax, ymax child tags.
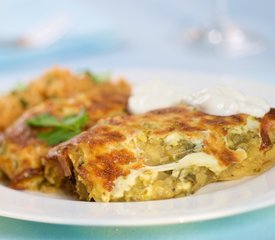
<box><xmin>27</xmin><ymin>110</ymin><xmax>89</xmax><ymax>145</ymax></box>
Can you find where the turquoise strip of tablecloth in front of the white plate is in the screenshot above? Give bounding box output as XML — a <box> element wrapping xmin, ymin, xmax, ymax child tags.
<box><xmin>0</xmin><ymin>204</ymin><xmax>275</xmax><ymax>240</ymax></box>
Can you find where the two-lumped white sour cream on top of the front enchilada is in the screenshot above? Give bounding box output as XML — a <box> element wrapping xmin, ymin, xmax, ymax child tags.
<box><xmin>128</xmin><ymin>81</ymin><xmax>270</xmax><ymax>117</ymax></box>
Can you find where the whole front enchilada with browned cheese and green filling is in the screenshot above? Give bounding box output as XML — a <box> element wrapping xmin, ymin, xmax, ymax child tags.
<box><xmin>47</xmin><ymin>104</ymin><xmax>275</xmax><ymax>202</ymax></box>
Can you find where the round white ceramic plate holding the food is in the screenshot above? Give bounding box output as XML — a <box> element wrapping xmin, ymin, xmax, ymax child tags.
<box><xmin>0</xmin><ymin>70</ymin><xmax>275</xmax><ymax>226</ymax></box>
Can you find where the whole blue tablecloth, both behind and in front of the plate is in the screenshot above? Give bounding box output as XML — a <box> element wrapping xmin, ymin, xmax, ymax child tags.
<box><xmin>0</xmin><ymin>0</ymin><xmax>275</xmax><ymax>239</ymax></box>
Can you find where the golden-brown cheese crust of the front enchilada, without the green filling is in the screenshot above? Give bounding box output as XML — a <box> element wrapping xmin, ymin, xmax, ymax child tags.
<box><xmin>47</xmin><ymin>105</ymin><xmax>275</xmax><ymax>201</ymax></box>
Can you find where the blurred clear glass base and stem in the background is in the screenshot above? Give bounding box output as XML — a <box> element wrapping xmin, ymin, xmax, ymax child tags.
<box><xmin>184</xmin><ymin>0</ymin><xmax>266</xmax><ymax>57</ymax></box>
